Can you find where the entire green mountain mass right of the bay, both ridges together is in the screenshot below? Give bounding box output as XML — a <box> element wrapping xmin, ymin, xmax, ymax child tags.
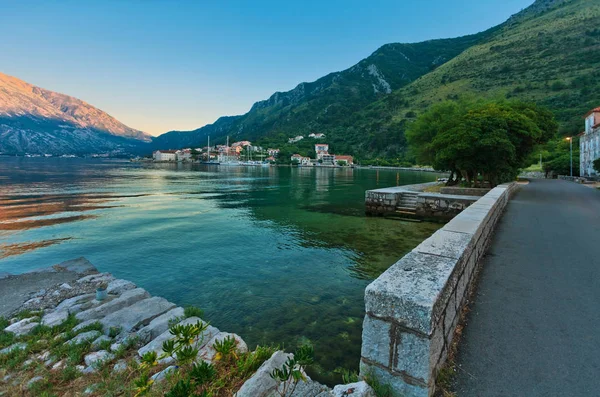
<box><xmin>152</xmin><ymin>0</ymin><xmax>600</xmax><ymax>159</ymax></box>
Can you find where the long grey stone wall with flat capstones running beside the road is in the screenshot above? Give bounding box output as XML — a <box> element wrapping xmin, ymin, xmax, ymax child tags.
<box><xmin>360</xmin><ymin>183</ymin><xmax>516</xmax><ymax>396</ymax></box>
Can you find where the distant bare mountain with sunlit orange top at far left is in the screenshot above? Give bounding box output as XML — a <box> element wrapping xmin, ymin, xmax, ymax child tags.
<box><xmin>0</xmin><ymin>73</ymin><xmax>151</xmax><ymax>154</ymax></box>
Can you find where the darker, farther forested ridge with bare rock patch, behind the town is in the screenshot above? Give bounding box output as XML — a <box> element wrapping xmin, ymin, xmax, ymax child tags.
<box><xmin>153</xmin><ymin>28</ymin><xmax>496</xmax><ymax>148</ymax></box>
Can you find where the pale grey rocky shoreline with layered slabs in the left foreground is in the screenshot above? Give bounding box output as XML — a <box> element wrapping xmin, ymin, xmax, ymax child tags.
<box><xmin>0</xmin><ymin>258</ymin><xmax>375</xmax><ymax>397</ymax></box>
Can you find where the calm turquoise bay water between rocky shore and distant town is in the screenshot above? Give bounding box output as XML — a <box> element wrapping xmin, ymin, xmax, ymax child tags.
<box><xmin>0</xmin><ymin>158</ymin><xmax>439</xmax><ymax>381</ymax></box>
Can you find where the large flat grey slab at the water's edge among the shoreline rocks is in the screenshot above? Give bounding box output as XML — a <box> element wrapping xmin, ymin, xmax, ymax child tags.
<box><xmin>100</xmin><ymin>296</ymin><xmax>175</xmax><ymax>332</ymax></box>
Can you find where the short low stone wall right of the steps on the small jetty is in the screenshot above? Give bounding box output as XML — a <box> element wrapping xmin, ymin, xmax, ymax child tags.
<box><xmin>416</xmin><ymin>193</ymin><xmax>481</xmax><ymax>221</ymax></box>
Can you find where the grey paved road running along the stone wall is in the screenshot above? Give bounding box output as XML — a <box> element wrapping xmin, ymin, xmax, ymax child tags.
<box><xmin>454</xmin><ymin>180</ymin><xmax>600</xmax><ymax>397</ymax></box>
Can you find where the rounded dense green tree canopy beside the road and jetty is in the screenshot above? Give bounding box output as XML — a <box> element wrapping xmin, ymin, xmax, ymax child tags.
<box><xmin>406</xmin><ymin>101</ymin><xmax>558</xmax><ymax>186</ymax></box>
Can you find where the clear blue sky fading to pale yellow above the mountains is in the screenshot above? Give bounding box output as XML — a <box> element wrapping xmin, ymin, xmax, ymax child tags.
<box><xmin>0</xmin><ymin>0</ymin><xmax>533</xmax><ymax>135</ymax></box>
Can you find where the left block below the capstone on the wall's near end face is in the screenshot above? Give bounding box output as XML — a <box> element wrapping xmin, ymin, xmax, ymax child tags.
<box><xmin>361</xmin><ymin>314</ymin><xmax>392</xmax><ymax>367</ymax></box>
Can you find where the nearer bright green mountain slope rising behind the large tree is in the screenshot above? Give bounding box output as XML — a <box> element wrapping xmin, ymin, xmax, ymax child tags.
<box><xmin>350</xmin><ymin>0</ymin><xmax>600</xmax><ymax>154</ymax></box>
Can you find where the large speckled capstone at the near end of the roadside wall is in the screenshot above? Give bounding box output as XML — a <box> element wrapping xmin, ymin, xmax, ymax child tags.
<box><xmin>365</xmin><ymin>251</ymin><xmax>457</xmax><ymax>335</ymax></box>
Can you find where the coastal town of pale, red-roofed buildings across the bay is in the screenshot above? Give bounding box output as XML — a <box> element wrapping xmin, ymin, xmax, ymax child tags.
<box><xmin>152</xmin><ymin>133</ymin><xmax>354</xmax><ymax>167</ymax></box>
